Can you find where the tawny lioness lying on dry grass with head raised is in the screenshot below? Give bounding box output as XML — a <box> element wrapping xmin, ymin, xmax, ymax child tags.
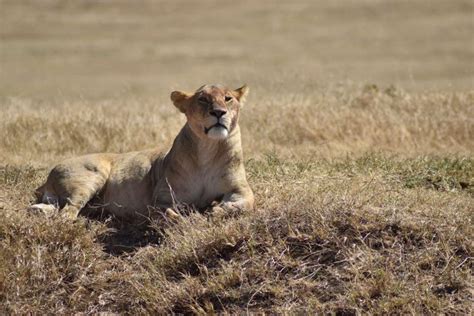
<box><xmin>30</xmin><ymin>85</ymin><xmax>254</xmax><ymax>218</ymax></box>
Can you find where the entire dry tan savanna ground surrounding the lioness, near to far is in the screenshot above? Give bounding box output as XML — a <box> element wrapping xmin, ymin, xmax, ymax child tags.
<box><xmin>0</xmin><ymin>0</ymin><xmax>474</xmax><ymax>315</ymax></box>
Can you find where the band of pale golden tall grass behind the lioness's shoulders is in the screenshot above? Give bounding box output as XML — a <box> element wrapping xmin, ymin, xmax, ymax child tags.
<box><xmin>0</xmin><ymin>85</ymin><xmax>474</xmax><ymax>164</ymax></box>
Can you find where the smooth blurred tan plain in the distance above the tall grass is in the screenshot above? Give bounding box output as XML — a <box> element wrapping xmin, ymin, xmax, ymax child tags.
<box><xmin>0</xmin><ymin>0</ymin><xmax>474</xmax><ymax>99</ymax></box>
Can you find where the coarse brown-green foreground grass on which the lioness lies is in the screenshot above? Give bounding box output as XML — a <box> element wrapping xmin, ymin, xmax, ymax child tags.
<box><xmin>0</xmin><ymin>154</ymin><xmax>474</xmax><ymax>314</ymax></box>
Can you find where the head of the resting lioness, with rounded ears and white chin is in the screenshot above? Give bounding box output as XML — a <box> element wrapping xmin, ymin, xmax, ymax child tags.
<box><xmin>171</xmin><ymin>85</ymin><xmax>249</xmax><ymax>140</ymax></box>
